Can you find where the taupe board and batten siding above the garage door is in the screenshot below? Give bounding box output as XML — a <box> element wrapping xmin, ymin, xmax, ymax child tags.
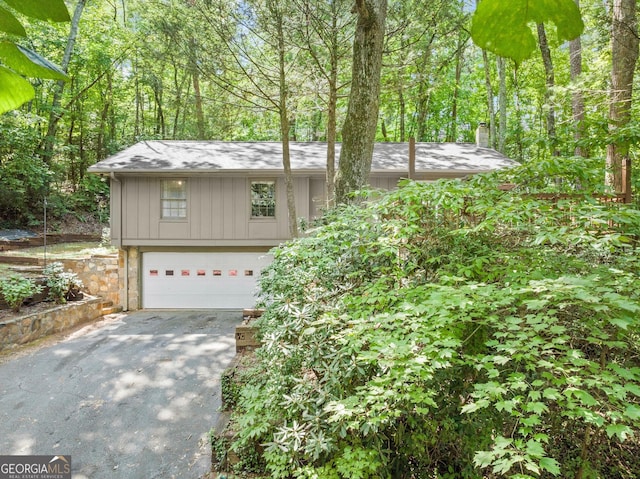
<box><xmin>111</xmin><ymin>176</ymin><xmax>317</xmax><ymax>246</ymax></box>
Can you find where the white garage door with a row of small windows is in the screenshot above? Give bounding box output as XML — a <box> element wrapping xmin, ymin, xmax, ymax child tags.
<box><xmin>142</xmin><ymin>252</ymin><xmax>272</xmax><ymax>309</ymax></box>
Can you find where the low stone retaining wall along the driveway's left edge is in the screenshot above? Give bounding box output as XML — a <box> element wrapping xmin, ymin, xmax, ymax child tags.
<box><xmin>0</xmin><ymin>297</ymin><xmax>103</xmax><ymax>351</ymax></box>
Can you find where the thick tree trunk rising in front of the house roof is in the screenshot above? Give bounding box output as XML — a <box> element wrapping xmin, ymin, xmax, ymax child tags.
<box><xmin>336</xmin><ymin>0</ymin><xmax>387</xmax><ymax>203</ymax></box>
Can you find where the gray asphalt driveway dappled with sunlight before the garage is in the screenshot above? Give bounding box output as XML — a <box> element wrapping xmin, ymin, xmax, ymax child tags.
<box><xmin>0</xmin><ymin>311</ymin><xmax>242</xmax><ymax>479</ymax></box>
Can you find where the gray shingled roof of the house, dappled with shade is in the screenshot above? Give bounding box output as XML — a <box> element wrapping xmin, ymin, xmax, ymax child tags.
<box><xmin>89</xmin><ymin>140</ymin><xmax>516</xmax><ymax>174</ymax></box>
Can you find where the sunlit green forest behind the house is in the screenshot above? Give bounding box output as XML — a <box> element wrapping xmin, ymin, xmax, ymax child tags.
<box><xmin>0</xmin><ymin>0</ymin><xmax>639</xmax><ymax>226</ymax></box>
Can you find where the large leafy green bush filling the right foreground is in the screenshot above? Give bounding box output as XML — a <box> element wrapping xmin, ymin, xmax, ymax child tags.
<box><xmin>233</xmin><ymin>160</ymin><xmax>640</xmax><ymax>478</ymax></box>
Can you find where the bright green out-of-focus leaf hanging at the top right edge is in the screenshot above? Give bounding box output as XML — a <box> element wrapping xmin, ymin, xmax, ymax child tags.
<box><xmin>471</xmin><ymin>0</ymin><xmax>584</xmax><ymax>63</ymax></box>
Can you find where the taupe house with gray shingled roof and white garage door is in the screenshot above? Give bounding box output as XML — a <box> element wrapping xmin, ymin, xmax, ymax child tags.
<box><xmin>89</xmin><ymin>140</ymin><xmax>514</xmax><ymax>309</ymax></box>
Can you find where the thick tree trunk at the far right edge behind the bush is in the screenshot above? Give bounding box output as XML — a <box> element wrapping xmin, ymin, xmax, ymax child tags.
<box><xmin>605</xmin><ymin>0</ymin><xmax>638</xmax><ymax>192</ymax></box>
